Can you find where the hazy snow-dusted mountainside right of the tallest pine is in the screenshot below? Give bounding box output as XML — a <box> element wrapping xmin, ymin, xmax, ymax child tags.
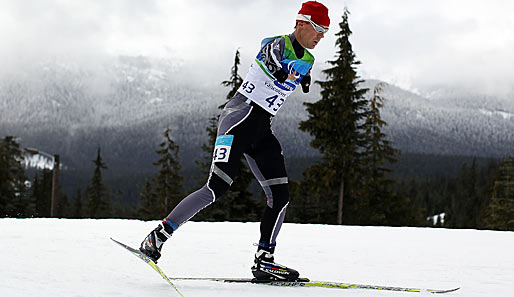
<box><xmin>366</xmin><ymin>81</ymin><xmax>514</xmax><ymax>157</ymax></box>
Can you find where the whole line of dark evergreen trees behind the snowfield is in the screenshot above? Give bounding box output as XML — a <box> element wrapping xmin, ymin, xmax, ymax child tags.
<box><xmin>0</xmin><ymin>10</ymin><xmax>514</xmax><ymax>230</ymax></box>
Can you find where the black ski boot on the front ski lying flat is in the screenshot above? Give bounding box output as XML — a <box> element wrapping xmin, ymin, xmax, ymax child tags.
<box><xmin>252</xmin><ymin>246</ymin><xmax>300</xmax><ymax>281</ymax></box>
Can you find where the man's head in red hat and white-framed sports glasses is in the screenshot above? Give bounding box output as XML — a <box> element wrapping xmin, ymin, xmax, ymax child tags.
<box><xmin>295</xmin><ymin>1</ymin><xmax>330</xmax><ymax>49</ymax></box>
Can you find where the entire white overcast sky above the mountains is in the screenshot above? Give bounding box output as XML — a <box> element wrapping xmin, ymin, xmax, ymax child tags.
<box><xmin>0</xmin><ymin>0</ymin><xmax>514</xmax><ymax>94</ymax></box>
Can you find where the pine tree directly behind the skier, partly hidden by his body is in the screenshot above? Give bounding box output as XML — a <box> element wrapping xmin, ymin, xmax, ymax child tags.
<box><xmin>196</xmin><ymin>50</ymin><xmax>258</xmax><ymax>221</ymax></box>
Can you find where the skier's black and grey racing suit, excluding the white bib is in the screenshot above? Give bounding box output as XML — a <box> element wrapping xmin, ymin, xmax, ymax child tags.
<box><xmin>166</xmin><ymin>34</ymin><xmax>304</xmax><ymax>247</ymax></box>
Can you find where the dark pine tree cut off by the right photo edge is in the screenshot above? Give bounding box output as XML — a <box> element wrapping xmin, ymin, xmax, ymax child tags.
<box><xmin>484</xmin><ymin>158</ymin><xmax>514</xmax><ymax>231</ymax></box>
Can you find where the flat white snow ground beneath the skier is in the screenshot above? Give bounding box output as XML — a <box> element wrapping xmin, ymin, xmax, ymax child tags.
<box><xmin>0</xmin><ymin>219</ymin><xmax>514</xmax><ymax>297</ymax></box>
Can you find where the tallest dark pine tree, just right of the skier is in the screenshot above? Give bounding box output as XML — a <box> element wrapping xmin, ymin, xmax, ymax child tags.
<box><xmin>300</xmin><ymin>8</ymin><xmax>368</xmax><ymax>224</ymax></box>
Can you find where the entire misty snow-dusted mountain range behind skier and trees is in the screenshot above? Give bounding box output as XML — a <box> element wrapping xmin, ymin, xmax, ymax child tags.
<box><xmin>0</xmin><ymin>56</ymin><xmax>514</xmax><ymax>176</ymax></box>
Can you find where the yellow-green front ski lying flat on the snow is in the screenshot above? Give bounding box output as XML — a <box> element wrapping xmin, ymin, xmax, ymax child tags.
<box><xmin>172</xmin><ymin>277</ymin><xmax>459</xmax><ymax>294</ymax></box>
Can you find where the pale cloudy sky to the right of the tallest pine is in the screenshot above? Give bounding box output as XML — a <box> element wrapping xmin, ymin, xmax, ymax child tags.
<box><xmin>350</xmin><ymin>1</ymin><xmax>514</xmax><ymax>94</ymax></box>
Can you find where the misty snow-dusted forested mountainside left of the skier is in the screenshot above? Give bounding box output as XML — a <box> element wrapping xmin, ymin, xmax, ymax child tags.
<box><xmin>0</xmin><ymin>57</ymin><xmax>225</xmax><ymax>173</ymax></box>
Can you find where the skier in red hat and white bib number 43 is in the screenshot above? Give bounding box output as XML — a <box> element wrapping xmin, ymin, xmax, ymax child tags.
<box><xmin>140</xmin><ymin>1</ymin><xmax>330</xmax><ymax>280</ymax></box>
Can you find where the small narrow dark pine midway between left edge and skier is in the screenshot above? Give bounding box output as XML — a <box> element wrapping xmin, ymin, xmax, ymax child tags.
<box><xmin>86</xmin><ymin>148</ymin><xmax>110</xmax><ymax>218</ymax></box>
